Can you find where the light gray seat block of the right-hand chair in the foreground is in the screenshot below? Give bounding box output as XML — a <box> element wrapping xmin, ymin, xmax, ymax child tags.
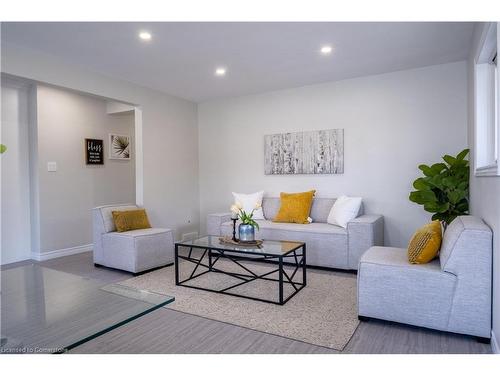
<box><xmin>358</xmin><ymin>246</ymin><xmax>457</xmax><ymax>329</ymax></box>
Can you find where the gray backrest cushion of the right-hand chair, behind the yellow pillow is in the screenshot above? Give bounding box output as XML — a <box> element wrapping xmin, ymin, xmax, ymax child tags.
<box><xmin>439</xmin><ymin>216</ymin><xmax>492</xmax><ymax>275</ymax></box>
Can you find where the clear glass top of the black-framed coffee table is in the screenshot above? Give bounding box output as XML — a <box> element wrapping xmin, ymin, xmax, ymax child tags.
<box><xmin>178</xmin><ymin>236</ymin><xmax>304</xmax><ymax>255</ymax></box>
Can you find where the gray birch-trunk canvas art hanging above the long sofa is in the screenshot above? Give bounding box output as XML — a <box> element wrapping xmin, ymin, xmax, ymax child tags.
<box><xmin>264</xmin><ymin>129</ymin><xmax>344</xmax><ymax>175</ymax></box>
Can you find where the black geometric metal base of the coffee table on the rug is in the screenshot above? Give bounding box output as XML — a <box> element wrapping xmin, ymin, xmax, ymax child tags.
<box><xmin>175</xmin><ymin>243</ymin><xmax>307</xmax><ymax>305</ymax></box>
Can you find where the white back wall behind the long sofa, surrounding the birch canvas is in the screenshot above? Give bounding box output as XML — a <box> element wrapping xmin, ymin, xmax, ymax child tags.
<box><xmin>198</xmin><ymin>62</ymin><xmax>467</xmax><ymax>246</ymax></box>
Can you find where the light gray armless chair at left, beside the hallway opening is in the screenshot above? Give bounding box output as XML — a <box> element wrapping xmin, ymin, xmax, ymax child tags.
<box><xmin>92</xmin><ymin>204</ymin><xmax>174</xmax><ymax>274</ymax></box>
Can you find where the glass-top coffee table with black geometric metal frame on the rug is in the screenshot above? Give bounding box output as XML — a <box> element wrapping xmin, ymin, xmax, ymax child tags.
<box><xmin>175</xmin><ymin>236</ymin><xmax>307</xmax><ymax>305</ymax></box>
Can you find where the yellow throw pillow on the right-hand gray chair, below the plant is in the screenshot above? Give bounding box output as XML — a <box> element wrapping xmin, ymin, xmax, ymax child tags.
<box><xmin>408</xmin><ymin>220</ymin><xmax>442</xmax><ymax>264</ymax></box>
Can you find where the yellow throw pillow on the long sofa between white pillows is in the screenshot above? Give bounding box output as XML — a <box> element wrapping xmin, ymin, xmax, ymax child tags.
<box><xmin>273</xmin><ymin>190</ymin><xmax>316</xmax><ymax>224</ymax></box>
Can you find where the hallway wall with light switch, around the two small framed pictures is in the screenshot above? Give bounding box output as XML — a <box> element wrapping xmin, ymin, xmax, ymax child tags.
<box><xmin>37</xmin><ymin>85</ymin><xmax>135</xmax><ymax>253</ymax></box>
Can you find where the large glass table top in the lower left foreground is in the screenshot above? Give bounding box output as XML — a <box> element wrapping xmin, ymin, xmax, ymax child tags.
<box><xmin>0</xmin><ymin>265</ymin><xmax>174</xmax><ymax>353</ymax></box>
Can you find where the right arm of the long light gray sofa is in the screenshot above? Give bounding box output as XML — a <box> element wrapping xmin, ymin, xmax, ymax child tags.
<box><xmin>347</xmin><ymin>214</ymin><xmax>384</xmax><ymax>269</ymax></box>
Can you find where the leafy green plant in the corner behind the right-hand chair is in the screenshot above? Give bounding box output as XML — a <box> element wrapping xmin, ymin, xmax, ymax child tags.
<box><xmin>410</xmin><ymin>149</ymin><xmax>469</xmax><ymax>229</ymax></box>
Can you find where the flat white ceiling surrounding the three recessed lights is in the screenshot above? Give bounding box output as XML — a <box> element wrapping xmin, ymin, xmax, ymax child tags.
<box><xmin>2</xmin><ymin>22</ymin><xmax>474</xmax><ymax>102</ymax></box>
